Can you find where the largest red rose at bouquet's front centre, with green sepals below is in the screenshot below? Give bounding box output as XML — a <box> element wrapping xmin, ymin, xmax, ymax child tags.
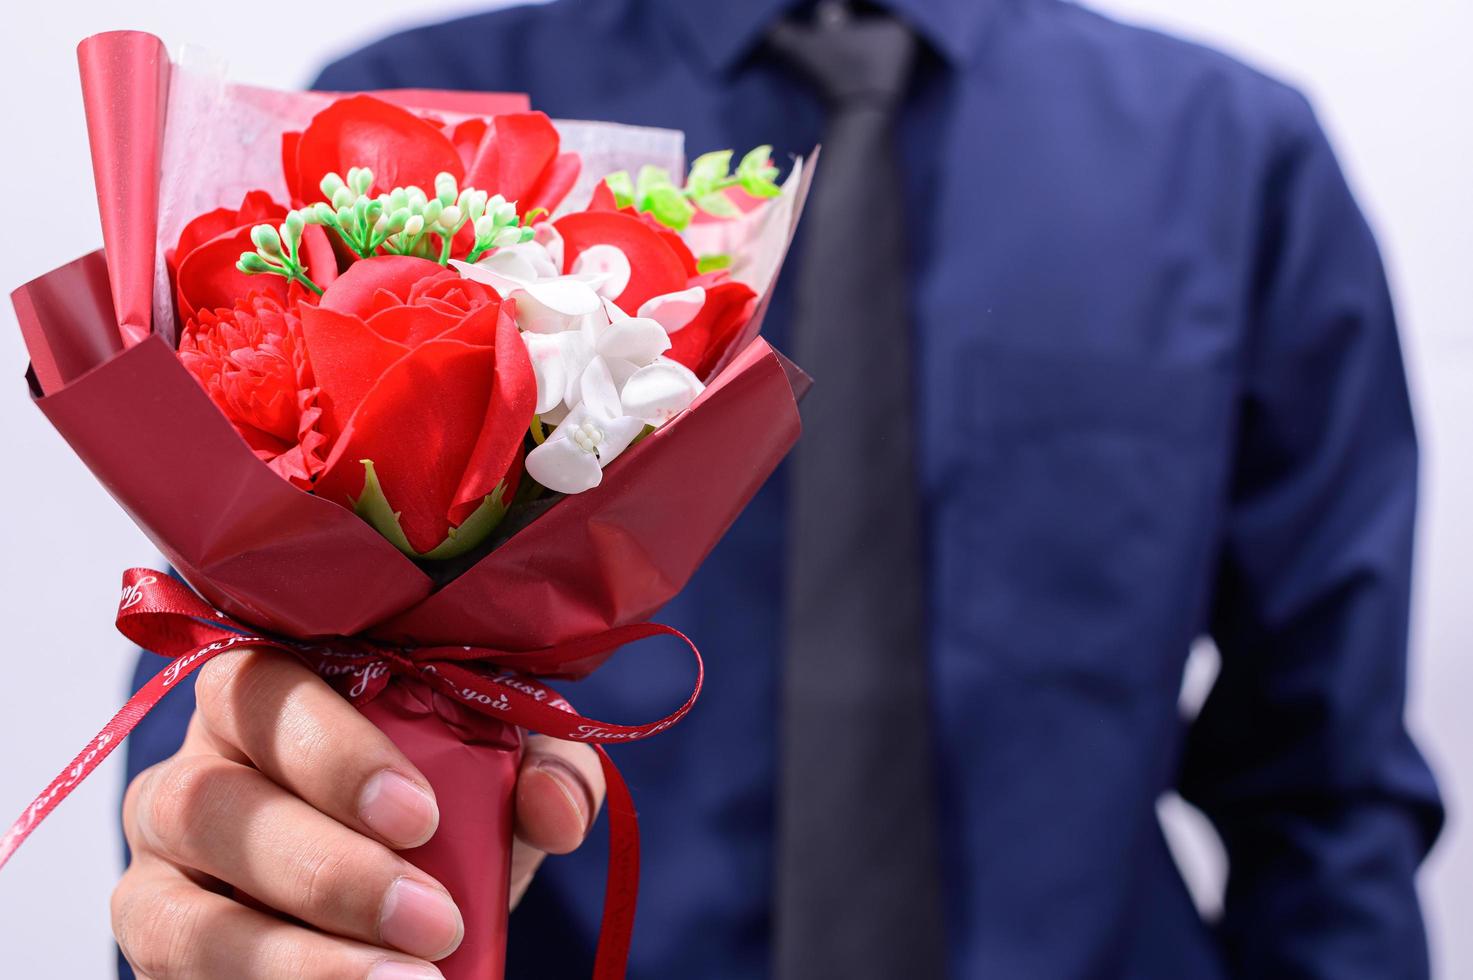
<box><xmin>300</xmin><ymin>255</ymin><xmax>536</xmax><ymax>557</ymax></box>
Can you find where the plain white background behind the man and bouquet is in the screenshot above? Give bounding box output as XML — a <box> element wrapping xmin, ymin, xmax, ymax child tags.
<box><xmin>0</xmin><ymin>0</ymin><xmax>1473</xmax><ymax>980</ymax></box>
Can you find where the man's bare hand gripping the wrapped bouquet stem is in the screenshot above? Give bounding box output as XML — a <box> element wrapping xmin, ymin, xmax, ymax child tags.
<box><xmin>112</xmin><ymin>650</ymin><xmax>604</xmax><ymax>980</ymax></box>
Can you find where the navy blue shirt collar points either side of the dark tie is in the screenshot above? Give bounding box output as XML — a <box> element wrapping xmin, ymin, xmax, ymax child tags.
<box><xmin>657</xmin><ymin>0</ymin><xmax>999</xmax><ymax>72</ymax></box>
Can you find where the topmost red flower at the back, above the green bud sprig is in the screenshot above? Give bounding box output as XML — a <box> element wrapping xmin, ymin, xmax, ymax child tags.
<box><xmin>281</xmin><ymin>96</ymin><xmax>579</xmax><ymax>214</ymax></box>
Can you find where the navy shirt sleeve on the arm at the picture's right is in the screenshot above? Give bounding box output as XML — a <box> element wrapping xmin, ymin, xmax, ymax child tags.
<box><xmin>1181</xmin><ymin>96</ymin><xmax>1442</xmax><ymax>980</ymax></box>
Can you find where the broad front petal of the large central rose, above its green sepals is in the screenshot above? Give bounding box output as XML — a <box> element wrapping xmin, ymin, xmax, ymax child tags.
<box><xmin>317</xmin><ymin>340</ymin><xmax>506</xmax><ymax>551</ymax></box>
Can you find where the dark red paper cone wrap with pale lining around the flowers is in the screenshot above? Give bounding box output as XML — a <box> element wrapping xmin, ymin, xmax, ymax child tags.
<box><xmin>0</xmin><ymin>26</ymin><xmax>807</xmax><ymax>980</ymax></box>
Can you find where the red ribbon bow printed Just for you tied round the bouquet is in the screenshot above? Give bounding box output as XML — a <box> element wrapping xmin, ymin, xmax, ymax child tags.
<box><xmin>0</xmin><ymin>569</ymin><xmax>706</xmax><ymax>980</ymax></box>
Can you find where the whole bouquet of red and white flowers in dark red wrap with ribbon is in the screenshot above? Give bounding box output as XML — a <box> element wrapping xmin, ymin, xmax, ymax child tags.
<box><xmin>0</xmin><ymin>32</ymin><xmax>807</xmax><ymax>977</ymax></box>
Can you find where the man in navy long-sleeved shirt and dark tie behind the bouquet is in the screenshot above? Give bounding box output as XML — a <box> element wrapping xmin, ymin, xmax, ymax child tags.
<box><xmin>111</xmin><ymin>0</ymin><xmax>1441</xmax><ymax>980</ymax></box>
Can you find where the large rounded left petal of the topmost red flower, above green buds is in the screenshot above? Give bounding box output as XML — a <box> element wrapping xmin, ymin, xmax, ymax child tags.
<box><xmin>295</xmin><ymin>96</ymin><xmax>465</xmax><ymax>202</ymax></box>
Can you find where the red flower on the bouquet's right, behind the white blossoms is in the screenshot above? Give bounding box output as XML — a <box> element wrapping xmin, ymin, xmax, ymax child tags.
<box><xmin>554</xmin><ymin>206</ymin><xmax>757</xmax><ymax>380</ymax></box>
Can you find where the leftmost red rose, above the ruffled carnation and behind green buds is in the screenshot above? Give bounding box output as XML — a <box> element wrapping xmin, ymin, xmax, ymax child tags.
<box><xmin>165</xmin><ymin>190</ymin><xmax>337</xmax><ymax>324</ymax></box>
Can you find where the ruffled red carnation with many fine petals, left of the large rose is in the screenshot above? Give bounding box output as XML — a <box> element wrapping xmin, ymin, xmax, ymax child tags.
<box><xmin>180</xmin><ymin>295</ymin><xmax>327</xmax><ymax>489</ymax></box>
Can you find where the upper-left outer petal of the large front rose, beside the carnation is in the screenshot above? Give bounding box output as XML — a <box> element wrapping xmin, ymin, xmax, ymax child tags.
<box><xmin>300</xmin><ymin>307</ymin><xmax>409</xmax><ymax>436</ymax></box>
